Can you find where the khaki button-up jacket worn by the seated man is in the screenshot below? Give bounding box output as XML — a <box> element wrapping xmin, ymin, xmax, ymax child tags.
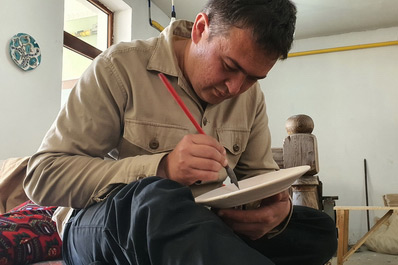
<box><xmin>24</xmin><ymin>21</ymin><xmax>278</xmax><ymax>235</ymax></box>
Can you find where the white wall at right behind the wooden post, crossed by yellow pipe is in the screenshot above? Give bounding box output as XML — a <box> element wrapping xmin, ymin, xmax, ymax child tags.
<box><xmin>261</xmin><ymin>28</ymin><xmax>398</xmax><ymax>240</ymax></box>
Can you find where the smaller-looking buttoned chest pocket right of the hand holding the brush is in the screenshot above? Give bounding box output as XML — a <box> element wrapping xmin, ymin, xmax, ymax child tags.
<box><xmin>217</xmin><ymin>128</ymin><xmax>250</xmax><ymax>167</ymax></box>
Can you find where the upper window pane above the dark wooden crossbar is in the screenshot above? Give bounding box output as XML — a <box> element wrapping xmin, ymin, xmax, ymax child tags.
<box><xmin>64</xmin><ymin>0</ymin><xmax>108</xmax><ymax>51</ymax></box>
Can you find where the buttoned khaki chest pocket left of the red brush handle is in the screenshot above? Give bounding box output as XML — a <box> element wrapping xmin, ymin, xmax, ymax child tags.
<box><xmin>123</xmin><ymin>120</ymin><xmax>188</xmax><ymax>155</ymax></box>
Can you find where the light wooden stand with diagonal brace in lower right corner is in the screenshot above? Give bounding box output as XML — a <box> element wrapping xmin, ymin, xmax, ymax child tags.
<box><xmin>334</xmin><ymin>206</ymin><xmax>398</xmax><ymax>265</ymax></box>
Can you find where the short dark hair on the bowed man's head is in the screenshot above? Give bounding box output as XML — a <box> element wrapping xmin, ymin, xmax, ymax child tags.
<box><xmin>202</xmin><ymin>0</ymin><xmax>297</xmax><ymax>59</ymax></box>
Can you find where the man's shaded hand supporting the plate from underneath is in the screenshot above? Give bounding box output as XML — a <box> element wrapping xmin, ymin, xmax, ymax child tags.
<box><xmin>217</xmin><ymin>190</ymin><xmax>292</xmax><ymax>240</ymax></box>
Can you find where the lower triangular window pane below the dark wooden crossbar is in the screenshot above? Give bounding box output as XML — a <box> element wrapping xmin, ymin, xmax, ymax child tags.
<box><xmin>61</xmin><ymin>48</ymin><xmax>92</xmax><ymax>106</ymax></box>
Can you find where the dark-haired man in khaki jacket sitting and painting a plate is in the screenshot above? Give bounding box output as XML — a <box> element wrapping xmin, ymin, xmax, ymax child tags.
<box><xmin>25</xmin><ymin>0</ymin><xmax>336</xmax><ymax>265</ymax></box>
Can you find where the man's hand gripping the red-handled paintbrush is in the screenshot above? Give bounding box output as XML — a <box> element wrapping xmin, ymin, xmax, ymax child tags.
<box><xmin>159</xmin><ymin>134</ymin><xmax>228</xmax><ymax>185</ymax></box>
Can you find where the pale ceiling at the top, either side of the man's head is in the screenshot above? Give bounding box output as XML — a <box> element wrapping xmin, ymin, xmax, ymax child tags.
<box><xmin>152</xmin><ymin>0</ymin><xmax>398</xmax><ymax>39</ymax></box>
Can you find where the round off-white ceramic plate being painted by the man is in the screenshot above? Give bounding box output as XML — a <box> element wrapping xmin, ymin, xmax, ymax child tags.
<box><xmin>195</xmin><ymin>166</ymin><xmax>310</xmax><ymax>208</ymax></box>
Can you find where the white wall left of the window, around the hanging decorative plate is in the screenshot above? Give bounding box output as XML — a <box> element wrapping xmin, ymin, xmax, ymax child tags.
<box><xmin>0</xmin><ymin>0</ymin><xmax>64</xmax><ymax>159</ymax></box>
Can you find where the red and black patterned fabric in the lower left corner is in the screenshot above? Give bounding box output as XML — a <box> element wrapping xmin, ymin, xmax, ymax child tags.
<box><xmin>0</xmin><ymin>201</ymin><xmax>62</xmax><ymax>265</ymax></box>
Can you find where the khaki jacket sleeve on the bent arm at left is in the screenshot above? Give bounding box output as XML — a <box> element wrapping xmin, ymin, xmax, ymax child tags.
<box><xmin>24</xmin><ymin>52</ymin><xmax>164</xmax><ymax>208</ymax></box>
